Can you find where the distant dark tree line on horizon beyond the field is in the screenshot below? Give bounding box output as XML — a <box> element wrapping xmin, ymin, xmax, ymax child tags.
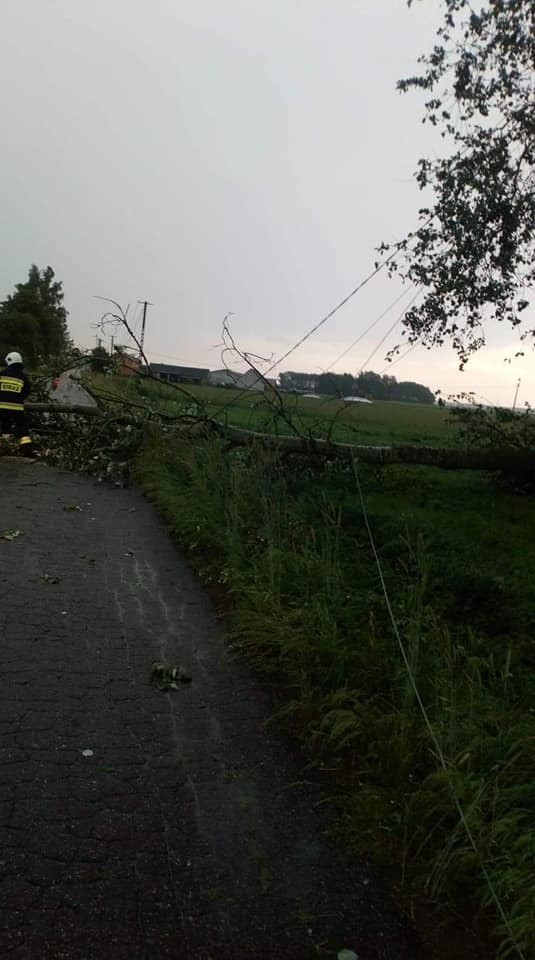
<box><xmin>279</xmin><ymin>370</ymin><xmax>435</xmax><ymax>403</ymax></box>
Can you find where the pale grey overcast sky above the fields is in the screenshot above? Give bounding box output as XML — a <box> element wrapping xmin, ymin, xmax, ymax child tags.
<box><xmin>0</xmin><ymin>0</ymin><xmax>535</xmax><ymax>403</ymax></box>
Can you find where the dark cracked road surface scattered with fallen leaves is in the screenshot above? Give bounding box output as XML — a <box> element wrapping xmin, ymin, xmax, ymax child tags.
<box><xmin>0</xmin><ymin>461</ymin><xmax>421</xmax><ymax>960</ymax></box>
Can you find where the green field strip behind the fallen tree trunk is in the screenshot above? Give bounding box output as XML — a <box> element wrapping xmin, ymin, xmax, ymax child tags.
<box><xmin>95</xmin><ymin>377</ymin><xmax>457</xmax><ymax>447</ymax></box>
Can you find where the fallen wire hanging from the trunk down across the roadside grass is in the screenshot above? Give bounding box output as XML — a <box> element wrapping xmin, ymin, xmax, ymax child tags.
<box><xmin>351</xmin><ymin>456</ymin><xmax>526</xmax><ymax>960</ymax></box>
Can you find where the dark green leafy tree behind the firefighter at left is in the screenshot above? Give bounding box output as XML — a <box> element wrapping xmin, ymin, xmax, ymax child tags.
<box><xmin>0</xmin><ymin>264</ymin><xmax>71</xmax><ymax>367</ymax></box>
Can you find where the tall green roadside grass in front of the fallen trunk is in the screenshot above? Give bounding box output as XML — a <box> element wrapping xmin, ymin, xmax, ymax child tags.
<box><xmin>135</xmin><ymin>436</ymin><xmax>535</xmax><ymax>957</ymax></box>
